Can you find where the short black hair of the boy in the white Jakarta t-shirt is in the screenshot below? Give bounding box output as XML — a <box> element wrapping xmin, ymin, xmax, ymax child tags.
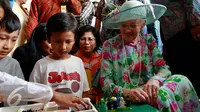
<box><xmin>47</xmin><ymin>13</ymin><xmax>77</xmax><ymax>39</ymax></box>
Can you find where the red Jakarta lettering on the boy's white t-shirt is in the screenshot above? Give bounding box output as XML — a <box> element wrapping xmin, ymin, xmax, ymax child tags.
<box><xmin>48</xmin><ymin>72</ymin><xmax>80</xmax><ymax>83</ymax></box>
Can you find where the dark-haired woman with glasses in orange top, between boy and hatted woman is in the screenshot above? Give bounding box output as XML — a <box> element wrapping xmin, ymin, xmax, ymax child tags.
<box><xmin>74</xmin><ymin>25</ymin><xmax>102</xmax><ymax>102</ymax></box>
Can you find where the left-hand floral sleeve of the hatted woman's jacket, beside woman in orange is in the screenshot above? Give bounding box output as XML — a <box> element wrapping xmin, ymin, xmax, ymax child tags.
<box><xmin>100</xmin><ymin>40</ymin><xmax>122</xmax><ymax>96</ymax></box>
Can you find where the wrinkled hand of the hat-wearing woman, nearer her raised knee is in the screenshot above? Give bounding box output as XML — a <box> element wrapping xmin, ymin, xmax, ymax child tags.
<box><xmin>143</xmin><ymin>79</ymin><xmax>160</xmax><ymax>107</ymax></box>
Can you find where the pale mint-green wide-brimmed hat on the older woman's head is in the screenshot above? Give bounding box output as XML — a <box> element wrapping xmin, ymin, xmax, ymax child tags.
<box><xmin>103</xmin><ymin>0</ymin><xmax>167</xmax><ymax>29</ymax></box>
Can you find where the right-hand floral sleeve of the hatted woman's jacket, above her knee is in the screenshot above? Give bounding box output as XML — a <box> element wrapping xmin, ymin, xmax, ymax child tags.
<box><xmin>147</xmin><ymin>35</ymin><xmax>171</xmax><ymax>83</ymax></box>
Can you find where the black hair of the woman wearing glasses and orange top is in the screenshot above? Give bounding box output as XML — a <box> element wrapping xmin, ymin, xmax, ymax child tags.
<box><xmin>75</xmin><ymin>25</ymin><xmax>102</xmax><ymax>51</ymax></box>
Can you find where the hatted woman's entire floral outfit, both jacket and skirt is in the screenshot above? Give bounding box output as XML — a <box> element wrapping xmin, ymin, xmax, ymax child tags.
<box><xmin>100</xmin><ymin>35</ymin><xmax>200</xmax><ymax>112</ymax></box>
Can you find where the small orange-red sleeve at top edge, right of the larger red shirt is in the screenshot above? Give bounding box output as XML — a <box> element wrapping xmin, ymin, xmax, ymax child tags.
<box><xmin>68</xmin><ymin>0</ymin><xmax>82</xmax><ymax>15</ymax></box>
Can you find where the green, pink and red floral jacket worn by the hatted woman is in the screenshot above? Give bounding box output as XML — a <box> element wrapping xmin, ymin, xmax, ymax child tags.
<box><xmin>100</xmin><ymin>35</ymin><xmax>171</xmax><ymax>95</ymax></box>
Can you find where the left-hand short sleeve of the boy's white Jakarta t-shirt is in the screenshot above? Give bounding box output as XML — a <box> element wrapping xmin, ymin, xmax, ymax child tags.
<box><xmin>29</xmin><ymin>61</ymin><xmax>42</xmax><ymax>83</ymax></box>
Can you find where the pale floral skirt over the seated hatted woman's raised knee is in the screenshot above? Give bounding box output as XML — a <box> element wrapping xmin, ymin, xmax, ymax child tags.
<box><xmin>158</xmin><ymin>75</ymin><xmax>200</xmax><ymax>112</ymax></box>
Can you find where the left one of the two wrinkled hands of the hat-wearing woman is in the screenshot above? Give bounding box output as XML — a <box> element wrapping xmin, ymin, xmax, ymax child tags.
<box><xmin>124</xmin><ymin>88</ymin><xmax>149</xmax><ymax>103</ymax></box>
